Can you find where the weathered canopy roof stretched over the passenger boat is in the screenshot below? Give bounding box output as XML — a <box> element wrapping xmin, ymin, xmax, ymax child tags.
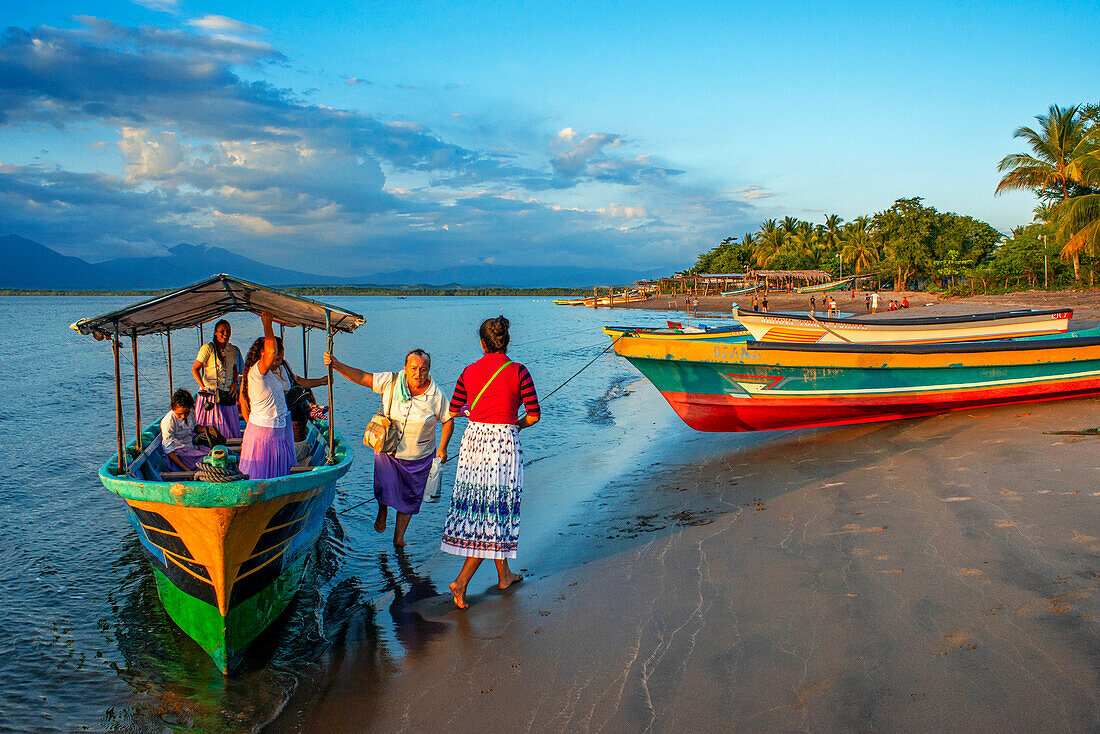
<box><xmin>72</xmin><ymin>274</ymin><xmax>363</xmax><ymax>339</ymax></box>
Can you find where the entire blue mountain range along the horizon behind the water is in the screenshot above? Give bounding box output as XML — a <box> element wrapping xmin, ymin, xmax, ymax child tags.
<box><xmin>0</xmin><ymin>234</ymin><xmax>661</xmax><ymax>291</ymax></box>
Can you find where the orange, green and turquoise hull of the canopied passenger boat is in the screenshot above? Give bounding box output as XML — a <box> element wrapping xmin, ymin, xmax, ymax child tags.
<box><xmin>100</xmin><ymin>424</ymin><xmax>351</xmax><ymax>672</ymax></box>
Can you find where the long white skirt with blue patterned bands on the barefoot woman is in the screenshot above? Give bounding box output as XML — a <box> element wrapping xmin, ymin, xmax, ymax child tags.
<box><xmin>441</xmin><ymin>423</ymin><xmax>524</xmax><ymax>559</ymax></box>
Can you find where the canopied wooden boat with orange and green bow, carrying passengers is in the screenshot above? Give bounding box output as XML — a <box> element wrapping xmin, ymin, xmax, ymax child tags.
<box><xmin>73</xmin><ymin>275</ymin><xmax>363</xmax><ymax>672</ymax></box>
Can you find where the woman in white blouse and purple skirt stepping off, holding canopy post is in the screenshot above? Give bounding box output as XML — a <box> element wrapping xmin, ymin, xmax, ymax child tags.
<box><xmin>325</xmin><ymin>349</ymin><xmax>454</xmax><ymax>548</ymax></box>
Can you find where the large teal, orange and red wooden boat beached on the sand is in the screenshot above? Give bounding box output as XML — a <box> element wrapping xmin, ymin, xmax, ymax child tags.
<box><xmin>614</xmin><ymin>329</ymin><xmax>1100</xmax><ymax>431</ymax></box>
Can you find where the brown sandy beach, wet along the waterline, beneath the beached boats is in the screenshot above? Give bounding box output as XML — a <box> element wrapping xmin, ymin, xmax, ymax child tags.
<box><xmin>270</xmin><ymin>294</ymin><xmax>1100</xmax><ymax>732</ymax></box>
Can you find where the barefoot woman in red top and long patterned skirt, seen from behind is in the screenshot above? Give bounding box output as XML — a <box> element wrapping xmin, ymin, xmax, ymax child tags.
<box><xmin>441</xmin><ymin>316</ymin><xmax>541</xmax><ymax>609</ymax></box>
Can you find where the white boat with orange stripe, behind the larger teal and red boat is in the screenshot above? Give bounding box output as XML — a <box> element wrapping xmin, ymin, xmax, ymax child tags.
<box><xmin>734</xmin><ymin>309</ymin><xmax>1074</xmax><ymax>344</ymax></box>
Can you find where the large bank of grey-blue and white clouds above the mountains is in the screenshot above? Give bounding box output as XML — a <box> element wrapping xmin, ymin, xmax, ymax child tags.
<box><xmin>0</xmin><ymin>15</ymin><xmax>751</xmax><ymax>274</ymax></box>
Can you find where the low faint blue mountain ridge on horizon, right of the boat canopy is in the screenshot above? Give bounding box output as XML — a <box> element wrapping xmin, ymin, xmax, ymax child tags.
<box><xmin>355</xmin><ymin>265</ymin><xmax>666</xmax><ymax>288</ymax></box>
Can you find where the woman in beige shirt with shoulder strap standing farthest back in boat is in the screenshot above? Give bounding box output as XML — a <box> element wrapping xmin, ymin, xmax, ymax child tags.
<box><xmin>191</xmin><ymin>319</ymin><xmax>241</xmax><ymax>438</ymax></box>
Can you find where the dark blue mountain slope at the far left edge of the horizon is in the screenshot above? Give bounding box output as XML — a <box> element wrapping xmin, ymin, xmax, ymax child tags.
<box><xmin>0</xmin><ymin>234</ymin><xmax>108</xmax><ymax>291</ymax></box>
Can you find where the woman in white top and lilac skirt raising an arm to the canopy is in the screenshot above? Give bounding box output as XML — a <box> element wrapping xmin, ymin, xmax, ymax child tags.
<box><xmin>239</xmin><ymin>311</ymin><xmax>295</xmax><ymax>479</ymax></box>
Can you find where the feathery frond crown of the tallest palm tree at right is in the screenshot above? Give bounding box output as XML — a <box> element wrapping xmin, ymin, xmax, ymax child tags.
<box><xmin>994</xmin><ymin>105</ymin><xmax>1095</xmax><ymax>200</ymax></box>
